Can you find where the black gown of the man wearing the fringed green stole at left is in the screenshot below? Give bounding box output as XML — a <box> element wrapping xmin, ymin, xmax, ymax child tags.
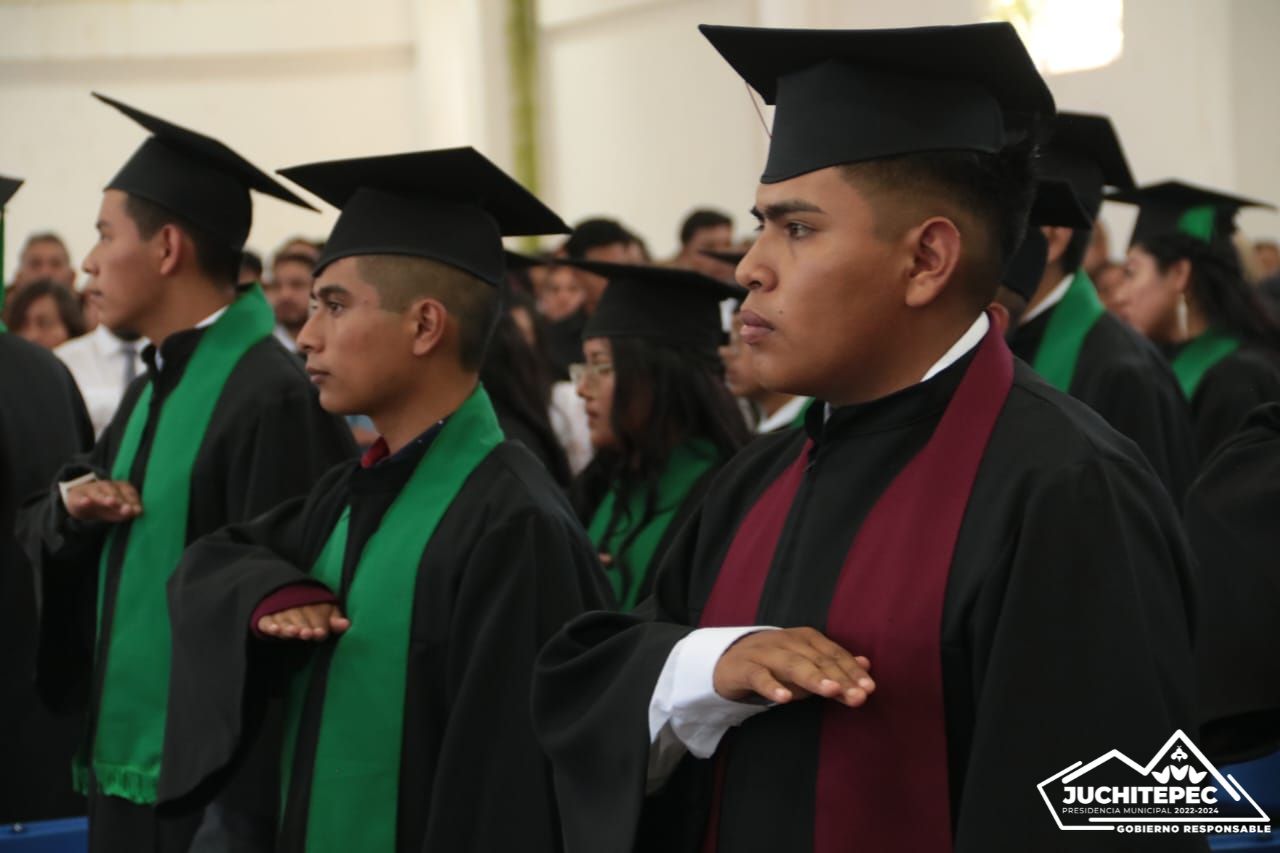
<box><xmin>19</xmin><ymin>329</ymin><xmax>356</xmax><ymax>853</ymax></box>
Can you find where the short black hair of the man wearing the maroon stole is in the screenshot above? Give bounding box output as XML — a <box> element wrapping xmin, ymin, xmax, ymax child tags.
<box><xmin>842</xmin><ymin>134</ymin><xmax>1036</xmax><ymax>305</ymax></box>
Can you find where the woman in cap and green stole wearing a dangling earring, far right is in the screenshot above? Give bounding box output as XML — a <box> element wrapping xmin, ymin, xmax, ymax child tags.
<box><xmin>1108</xmin><ymin>175</ymin><xmax>1280</xmax><ymax>465</ymax></box>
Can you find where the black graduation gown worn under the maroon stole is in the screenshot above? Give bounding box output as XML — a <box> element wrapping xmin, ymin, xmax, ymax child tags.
<box><xmin>534</xmin><ymin>355</ymin><xmax>1199</xmax><ymax>853</ymax></box>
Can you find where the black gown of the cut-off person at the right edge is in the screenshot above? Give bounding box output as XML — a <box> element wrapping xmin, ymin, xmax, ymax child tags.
<box><xmin>1184</xmin><ymin>403</ymin><xmax>1280</xmax><ymax>761</ymax></box>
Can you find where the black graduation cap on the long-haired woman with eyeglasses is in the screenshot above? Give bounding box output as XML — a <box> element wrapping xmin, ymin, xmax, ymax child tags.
<box><xmin>563</xmin><ymin>260</ymin><xmax>746</xmax><ymax>356</ymax></box>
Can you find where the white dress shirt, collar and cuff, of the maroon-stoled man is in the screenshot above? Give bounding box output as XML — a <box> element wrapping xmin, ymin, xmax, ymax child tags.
<box><xmin>648</xmin><ymin>314</ymin><xmax>991</xmax><ymax>792</ymax></box>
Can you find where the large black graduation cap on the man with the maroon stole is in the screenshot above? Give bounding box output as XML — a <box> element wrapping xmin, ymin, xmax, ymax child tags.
<box><xmin>699</xmin><ymin>23</ymin><xmax>1053</xmax><ymax>183</ymax></box>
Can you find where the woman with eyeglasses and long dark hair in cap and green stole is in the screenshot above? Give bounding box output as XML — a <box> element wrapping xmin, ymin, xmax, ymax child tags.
<box><xmin>570</xmin><ymin>261</ymin><xmax>750</xmax><ymax>610</ymax></box>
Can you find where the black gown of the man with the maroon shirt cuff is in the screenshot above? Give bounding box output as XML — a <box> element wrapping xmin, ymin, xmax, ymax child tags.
<box><xmin>160</xmin><ymin>442</ymin><xmax>605</xmax><ymax>853</ymax></box>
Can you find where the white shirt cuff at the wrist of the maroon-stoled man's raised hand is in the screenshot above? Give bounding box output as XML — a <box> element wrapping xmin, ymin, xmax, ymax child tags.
<box><xmin>649</xmin><ymin>625</ymin><xmax>776</xmax><ymax>758</ymax></box>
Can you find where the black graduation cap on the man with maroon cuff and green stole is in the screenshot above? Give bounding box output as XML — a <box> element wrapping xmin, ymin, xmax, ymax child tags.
<box><xmin>280</xmin><ymin>147</ymin><xmax>568</xmax><ymax>287</ymax></box>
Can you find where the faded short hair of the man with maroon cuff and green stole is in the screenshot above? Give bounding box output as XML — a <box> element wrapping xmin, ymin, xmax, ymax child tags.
<box><xmin>356</xmin><ymin>255</ymin><xmax>498</xmax><ymax>371</ymax></box>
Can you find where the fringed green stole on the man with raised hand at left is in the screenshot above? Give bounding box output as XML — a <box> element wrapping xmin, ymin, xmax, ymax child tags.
<box><xmin>77</xmin><ymin>287</ymin><xmax>275</xmax><ymax>803</ymax></box>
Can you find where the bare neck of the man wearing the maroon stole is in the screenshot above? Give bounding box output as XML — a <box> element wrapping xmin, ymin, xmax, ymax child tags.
<box><xmin>814</xmin><ymin>310</ymin><xmax>978</xmax><ymax>407</ymax></box>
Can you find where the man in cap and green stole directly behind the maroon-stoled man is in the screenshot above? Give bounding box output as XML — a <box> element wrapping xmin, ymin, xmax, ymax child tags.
<box><xmin>1009</xmin><ymin>113</ymin><xmax>1196</xmax><ymax>503</ymax></box>
